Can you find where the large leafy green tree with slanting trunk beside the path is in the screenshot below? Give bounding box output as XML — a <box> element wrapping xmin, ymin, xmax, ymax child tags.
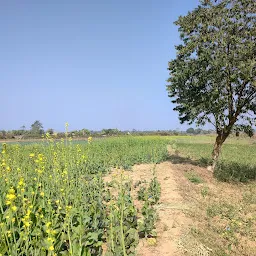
<box><xmin>167</xmin><ymin>0</ymin><xmax>256</xmax><ymax>169</ymax></box>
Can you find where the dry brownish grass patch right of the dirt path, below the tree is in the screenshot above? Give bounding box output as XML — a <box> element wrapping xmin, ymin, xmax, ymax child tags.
<box><xmin>175</xmin><ymin>164</ymin><xmax>256</xmax><ymax>256</ymax></box>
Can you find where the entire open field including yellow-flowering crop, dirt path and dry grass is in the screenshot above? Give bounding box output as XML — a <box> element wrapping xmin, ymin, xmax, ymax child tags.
<box><xmin>0</xmin><ymin>136</ymin><xmax>256</xmax><ymax>256</ymax></box>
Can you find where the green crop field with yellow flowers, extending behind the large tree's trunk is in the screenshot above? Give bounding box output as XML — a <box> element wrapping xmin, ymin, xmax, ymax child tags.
<box><xmin>0</xmin><ymin>136</ymin><xmax>256</xmax><ymax>256</ymax></box>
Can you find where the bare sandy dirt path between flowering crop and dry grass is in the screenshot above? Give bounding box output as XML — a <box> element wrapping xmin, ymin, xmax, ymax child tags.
<box><xmin>130</xmin><ymin>162</ymin><xmax>191</xmax><ymax>256</ymax></box>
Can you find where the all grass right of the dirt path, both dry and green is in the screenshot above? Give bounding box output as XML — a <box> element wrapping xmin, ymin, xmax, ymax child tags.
<box><xmin>171</xmin><ymin>137</ymin><xmax>256</xmax><ymax>256</ymax></box>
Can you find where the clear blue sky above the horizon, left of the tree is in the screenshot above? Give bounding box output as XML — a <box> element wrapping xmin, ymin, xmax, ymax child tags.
<box><xmin>0</xmin><ymin>0</ymin><xmax>199</xmax><ymax>131</ymax></box>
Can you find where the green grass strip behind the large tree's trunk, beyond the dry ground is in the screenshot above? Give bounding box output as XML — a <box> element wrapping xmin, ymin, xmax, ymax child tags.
<box><xmin>172</xmin><ymin>136</ymin><xmax>256</xmax><ymax>182</ymax></box>
